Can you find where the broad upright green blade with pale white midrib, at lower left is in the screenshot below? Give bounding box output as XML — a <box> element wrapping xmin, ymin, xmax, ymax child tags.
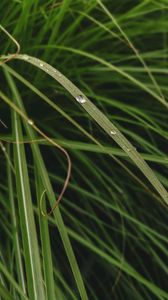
<box><xmin>12</xmin><ymin>111</ymin><xmax>45</xmax><ymax>300</ymax></box>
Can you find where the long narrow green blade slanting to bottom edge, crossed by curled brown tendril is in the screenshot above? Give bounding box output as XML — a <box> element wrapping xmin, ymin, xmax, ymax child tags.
<box><xmin>5</xmin><ymin>72</ymin><xmax>88</xmax><ymax>300</ymax></box>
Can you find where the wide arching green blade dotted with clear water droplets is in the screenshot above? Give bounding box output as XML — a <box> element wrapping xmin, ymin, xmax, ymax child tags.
<box><xmin>12</xmin><ymin>55</ymin><xmax>168</xmax><ymax>205</ymax></box>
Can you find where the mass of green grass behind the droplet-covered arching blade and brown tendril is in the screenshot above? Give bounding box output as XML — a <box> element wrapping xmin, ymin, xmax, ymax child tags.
<box><xmin>0</xmin><ymin>0</ymin><xmax>168</xmax><ymax>300</ymax></box>
